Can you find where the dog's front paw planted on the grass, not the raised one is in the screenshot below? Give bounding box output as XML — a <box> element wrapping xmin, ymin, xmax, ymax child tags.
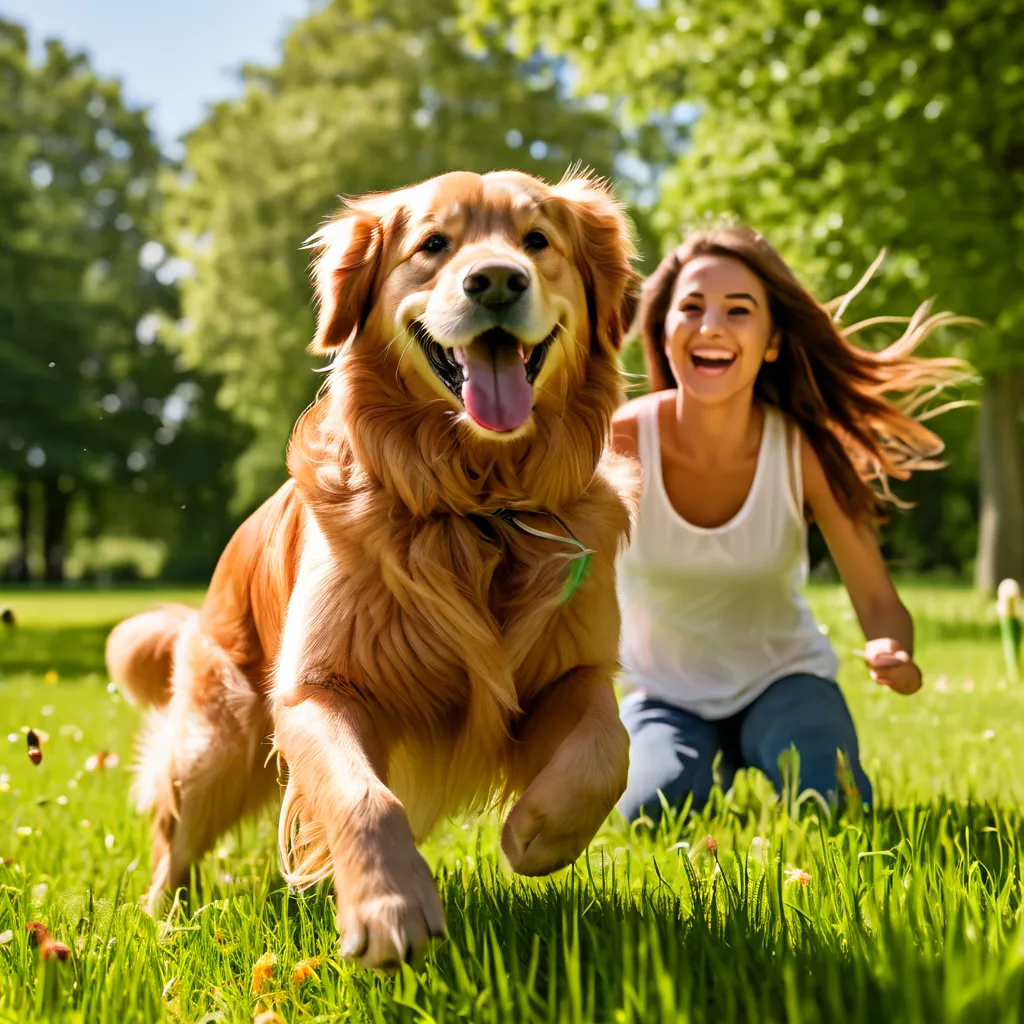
<box><xmin>336</xmin><ymin>847</ymin><xmax>447</xmax><ymax>971</ymax></box>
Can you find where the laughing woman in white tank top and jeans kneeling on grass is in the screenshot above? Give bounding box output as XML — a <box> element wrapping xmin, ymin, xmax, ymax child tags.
<box><xmin>615</xmin><ymin>220</ymin><xmax>966</xmax><ymax>818</ymax></box>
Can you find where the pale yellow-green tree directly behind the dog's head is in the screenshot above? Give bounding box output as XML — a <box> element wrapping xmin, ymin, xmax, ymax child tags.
<box><xmin>166</xmin><ymin>0</ymin><xmax>620</xmax><ymax>508</ymax></box>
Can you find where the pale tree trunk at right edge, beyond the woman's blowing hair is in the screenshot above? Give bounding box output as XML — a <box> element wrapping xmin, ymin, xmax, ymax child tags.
<box><xmin>975</xmin><ymin>370</ymin><xmax>1024</xmax><ymax>591</ymax></box>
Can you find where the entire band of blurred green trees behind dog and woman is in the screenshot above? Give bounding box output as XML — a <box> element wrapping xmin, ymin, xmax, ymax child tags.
<box><xmin>0</xmin><ymin>0</ymin><xmax>1024</xmax><ymax>587</ymax></box>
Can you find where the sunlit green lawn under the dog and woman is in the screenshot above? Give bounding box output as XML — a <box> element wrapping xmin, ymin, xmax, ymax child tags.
<box><xmin>0</xmin><ymin>585</ymin><xmax>1024</xmax><ymax>1024</ymax></box>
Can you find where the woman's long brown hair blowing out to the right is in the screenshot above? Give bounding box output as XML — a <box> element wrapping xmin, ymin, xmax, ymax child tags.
<box><xmin>639</xmin><ymin>224</ymin><xmax>976</xmax><ymax>521</ymax></box>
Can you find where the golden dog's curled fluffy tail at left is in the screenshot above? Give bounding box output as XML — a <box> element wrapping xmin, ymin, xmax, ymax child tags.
<box><xmin>106</xmin><ymin>604</ymin><xmax>199</xmax><ymax>708</ymax></box>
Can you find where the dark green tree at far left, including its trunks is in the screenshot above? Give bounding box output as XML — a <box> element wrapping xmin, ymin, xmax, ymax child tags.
<box><xmin>0</xmin><ymin>22</ymin><xmax>241</xmax><ymax>581</ymax></box>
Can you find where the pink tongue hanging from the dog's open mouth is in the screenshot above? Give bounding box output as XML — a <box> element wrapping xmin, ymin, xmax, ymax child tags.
<box><xmin>454</xmin><ymin>341</ymin><xmax>534</xmax><ymax>431</ymax></box>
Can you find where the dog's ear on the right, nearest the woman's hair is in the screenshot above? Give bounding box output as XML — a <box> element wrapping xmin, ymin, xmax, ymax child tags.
<box><xmin>551</xmin><ymin>171</ymin><xmax>640</xmax><ymax>350</ymax></box>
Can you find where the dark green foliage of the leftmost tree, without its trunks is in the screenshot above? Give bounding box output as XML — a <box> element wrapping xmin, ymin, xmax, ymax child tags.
<box><xmin>0</xmin><ymin>24</ymin><xmax>173</xmax><ymax>482</ymax></box>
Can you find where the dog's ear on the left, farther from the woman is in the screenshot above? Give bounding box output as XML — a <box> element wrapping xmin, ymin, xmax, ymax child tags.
<box><xmin>306</xmin><ymin>203</ymin><xmax>384</xmax><ymax>354</ymax></box>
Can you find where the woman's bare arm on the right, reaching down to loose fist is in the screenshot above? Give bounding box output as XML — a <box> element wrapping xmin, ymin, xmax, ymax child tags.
<box><xmin>801</xmin><ymin>436</ymin><xmax>922</xmax><ymax>693</ymax></box>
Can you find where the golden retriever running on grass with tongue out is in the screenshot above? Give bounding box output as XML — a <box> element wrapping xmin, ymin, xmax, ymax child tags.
<box><xmin>108</xmin><ymin>171</ymin><xmax>637</xmax><ymax>968</ymax></box>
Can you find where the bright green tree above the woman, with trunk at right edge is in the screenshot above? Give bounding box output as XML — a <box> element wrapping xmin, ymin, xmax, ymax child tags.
<box><xmin>467</xmin><ymin>0</ymin><xmax>1024</xmax><ymax>588</ymax></box>
